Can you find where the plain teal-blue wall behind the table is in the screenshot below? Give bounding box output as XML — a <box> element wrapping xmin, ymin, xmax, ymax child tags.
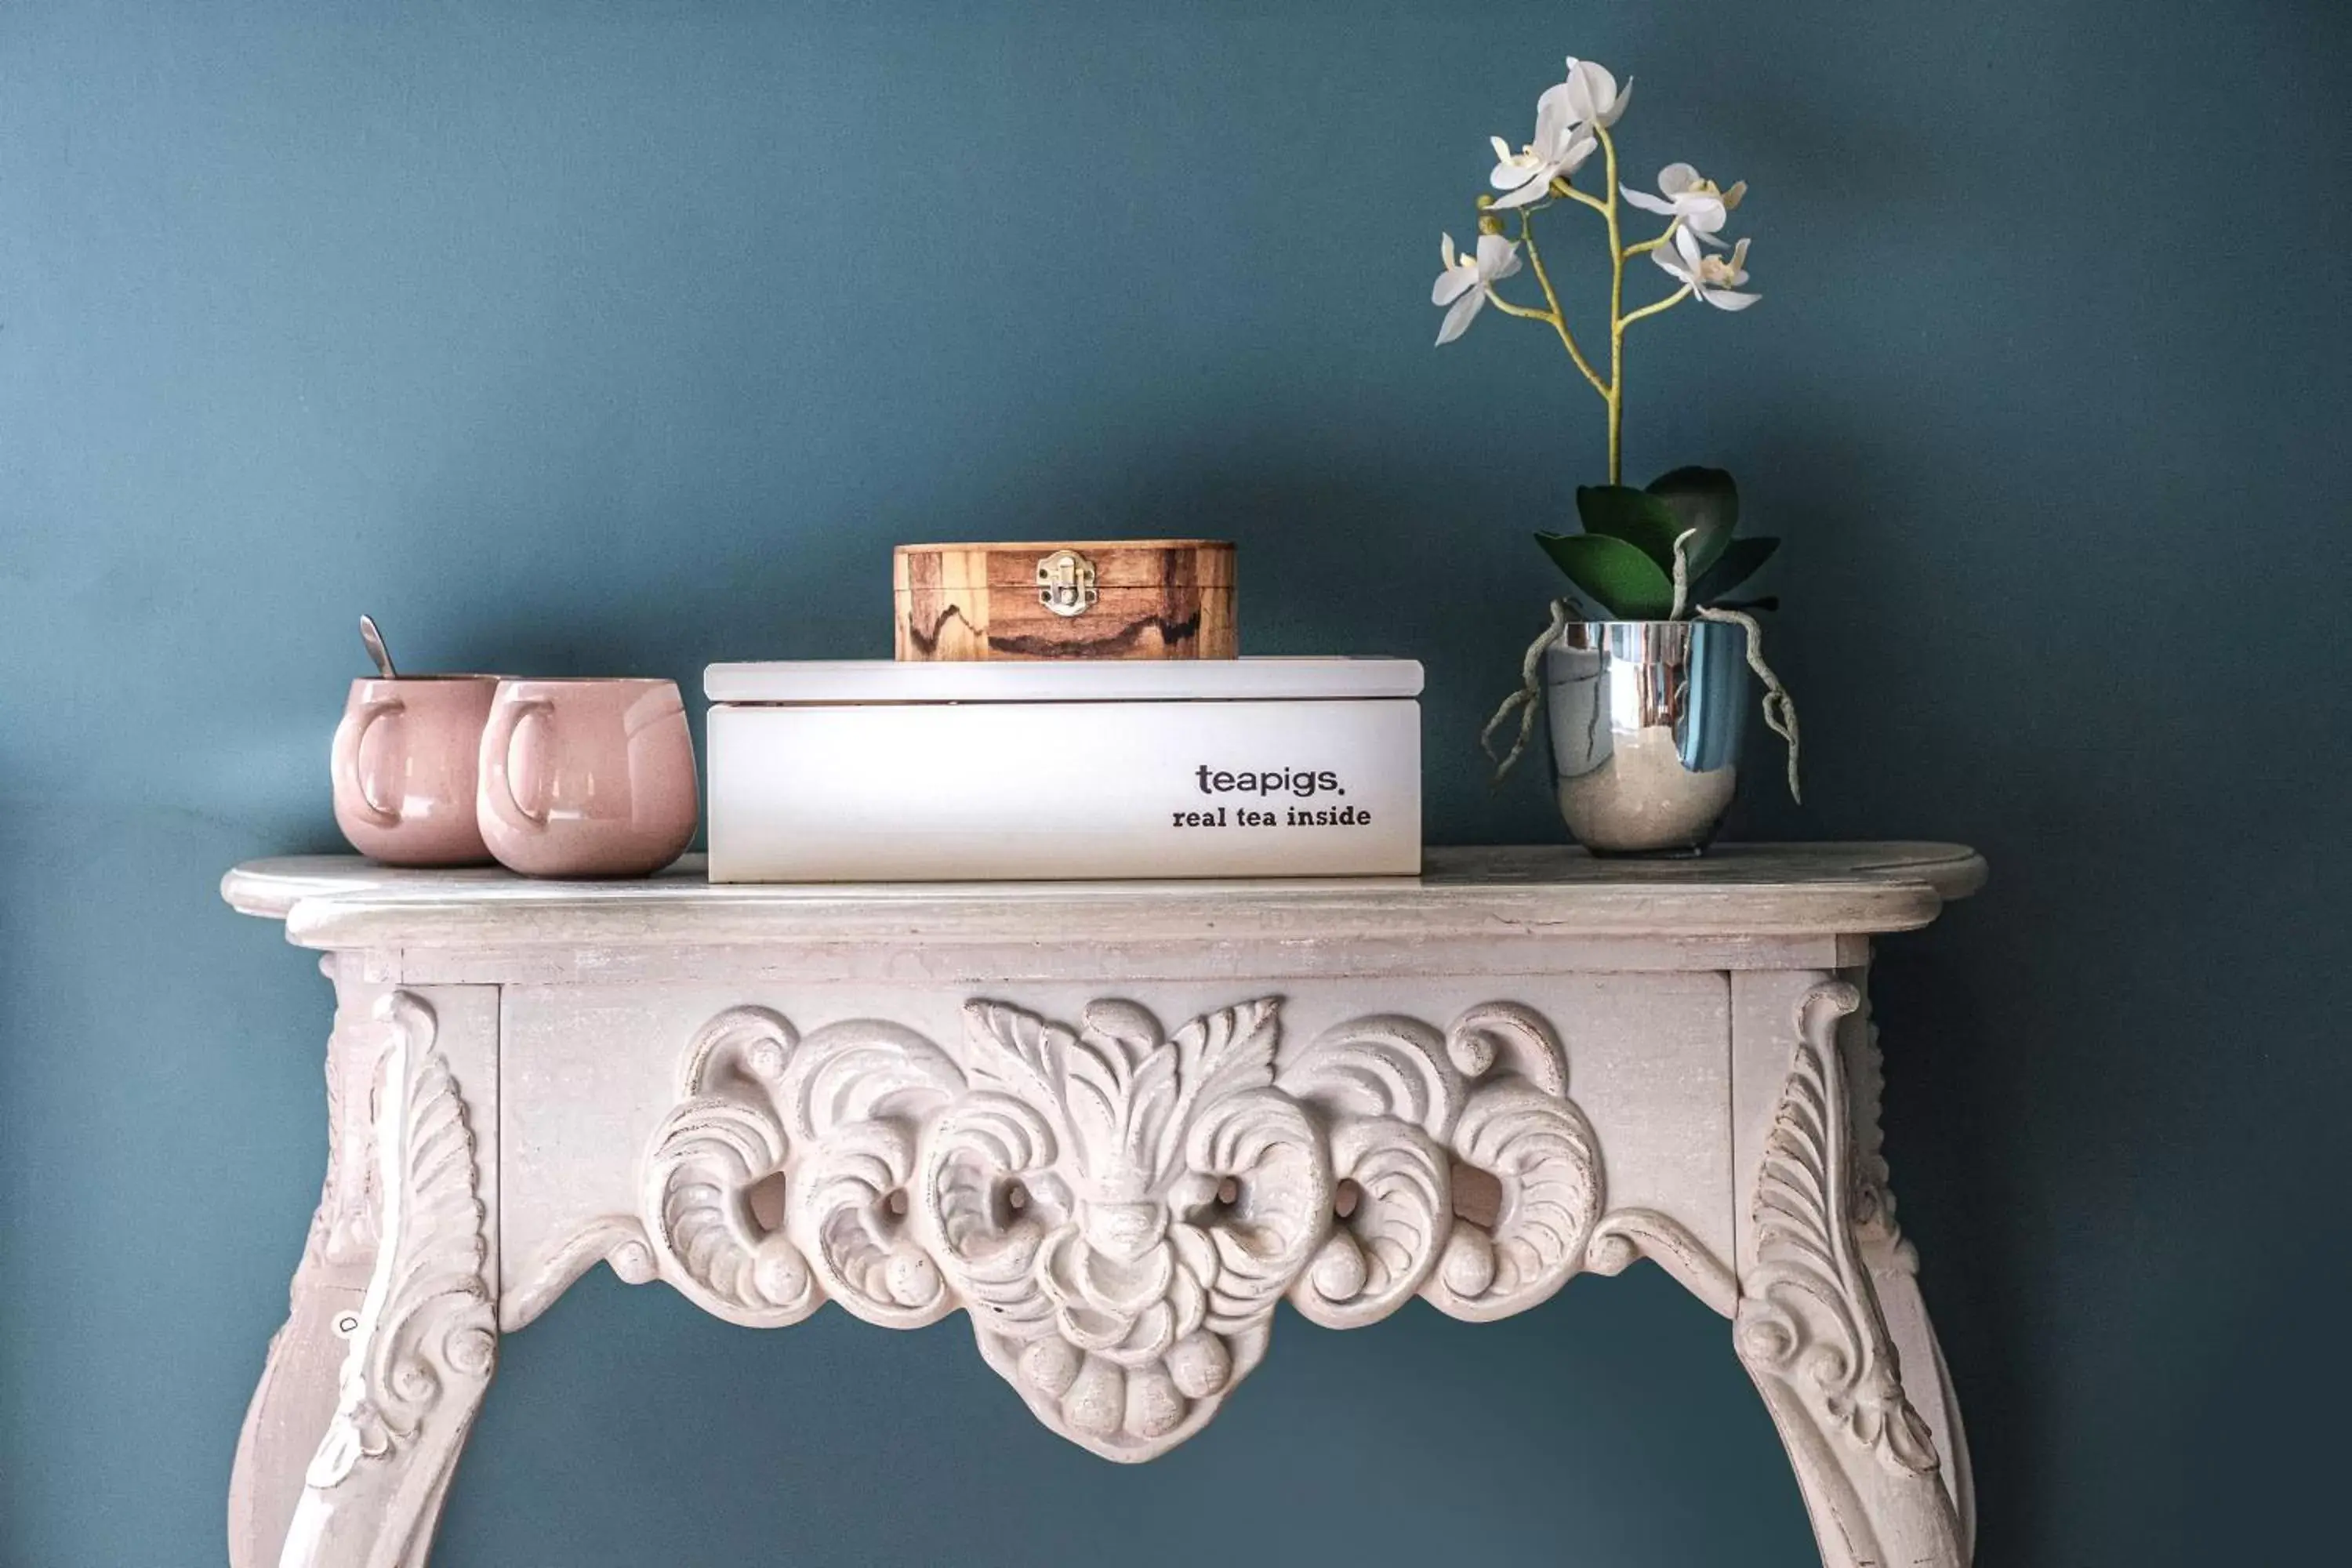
<box><xmin>0</xmin><ymin>0</ymin><xmax>2352</xmax><ymax>1568</ymax></box>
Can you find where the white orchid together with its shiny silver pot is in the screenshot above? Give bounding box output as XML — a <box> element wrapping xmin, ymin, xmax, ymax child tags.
<box><xmin>1430</xmin><ymin>56</ymin><xmax>1797</xmax><ymax>853</ymax></box>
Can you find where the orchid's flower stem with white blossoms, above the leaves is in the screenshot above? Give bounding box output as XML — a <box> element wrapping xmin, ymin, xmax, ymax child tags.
<box><xmin>1430</xmin><ymin>56</ymin><xmax>1759</xmax><ymax>485</ymax></box>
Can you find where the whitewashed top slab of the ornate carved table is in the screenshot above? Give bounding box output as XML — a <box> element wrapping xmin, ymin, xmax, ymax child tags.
<box><xmin>221</xmin><ymin>844</ymin><xmax>1985</xmax><ymax>947</ymax></box>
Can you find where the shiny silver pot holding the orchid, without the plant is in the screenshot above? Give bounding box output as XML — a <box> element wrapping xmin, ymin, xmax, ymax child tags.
<box><xmin>1543</xmin><ymin>621</ymin><xmax>1755</xmax><ymax>855</ymax></box>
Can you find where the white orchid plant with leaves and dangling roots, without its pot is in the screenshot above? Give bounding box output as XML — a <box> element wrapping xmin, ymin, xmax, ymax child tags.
<box><xmin>1430</xmin><ymin>54</ymin><xmax>1797</xmax><ymax>794</ymax></box>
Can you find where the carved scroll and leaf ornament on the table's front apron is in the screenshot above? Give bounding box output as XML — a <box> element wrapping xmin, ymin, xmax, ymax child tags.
<box><xmin>532</xmin><ymin>996</ymin><xmax>1665</xmax><ymax>1460</ymax></box>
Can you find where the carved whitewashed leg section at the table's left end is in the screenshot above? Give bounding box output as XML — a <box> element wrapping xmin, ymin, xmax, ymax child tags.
<box><xmin>228</xmin><ymin>989</ymin><xmax>499</xmax><ymax>1568</ymax></box>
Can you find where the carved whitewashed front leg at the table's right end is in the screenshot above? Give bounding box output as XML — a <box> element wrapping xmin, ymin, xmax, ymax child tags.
<box><xmin>1733</xmin><ymin>980</ymin><xmax>1969</xmax><ymax>1568</ymax></box>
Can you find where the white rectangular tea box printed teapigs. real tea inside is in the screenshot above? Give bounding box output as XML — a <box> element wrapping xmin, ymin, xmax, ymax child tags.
<box><xmin>703</xmin><ymin>659</ymin><xmax>1421</xmax><ymax>881</ymax></box>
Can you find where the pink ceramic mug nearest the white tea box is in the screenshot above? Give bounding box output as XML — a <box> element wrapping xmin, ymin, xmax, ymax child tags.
<box><xmin>477</xmin><ymin>680</ymin><xmax>696</xmax><ymax>877</ymax></box>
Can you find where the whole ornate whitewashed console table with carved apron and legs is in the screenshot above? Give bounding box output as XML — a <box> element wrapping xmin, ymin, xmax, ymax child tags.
<box><xmin>223</xmin><ymin>844</ymin><xmax>1983</xmax><ymax>1568</ymax></box>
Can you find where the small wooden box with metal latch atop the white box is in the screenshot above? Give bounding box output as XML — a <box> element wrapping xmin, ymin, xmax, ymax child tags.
<box><xmin>891</xmin><ymin>539</ymin><xmax>1240</xmax><ymax>661</ymax></box>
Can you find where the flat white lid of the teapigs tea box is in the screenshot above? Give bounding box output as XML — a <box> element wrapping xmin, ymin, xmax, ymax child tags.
<box><xmin>703</xmin><ymin>659</ymin><xmax>1421</xmax><ymax>703</ymax></box>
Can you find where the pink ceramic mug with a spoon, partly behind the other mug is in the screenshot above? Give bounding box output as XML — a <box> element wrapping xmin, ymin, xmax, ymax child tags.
<box><xmin>332</xmin><ymin>675</ymin><xmax>499</xmax><ymax>865</ymax></box>
